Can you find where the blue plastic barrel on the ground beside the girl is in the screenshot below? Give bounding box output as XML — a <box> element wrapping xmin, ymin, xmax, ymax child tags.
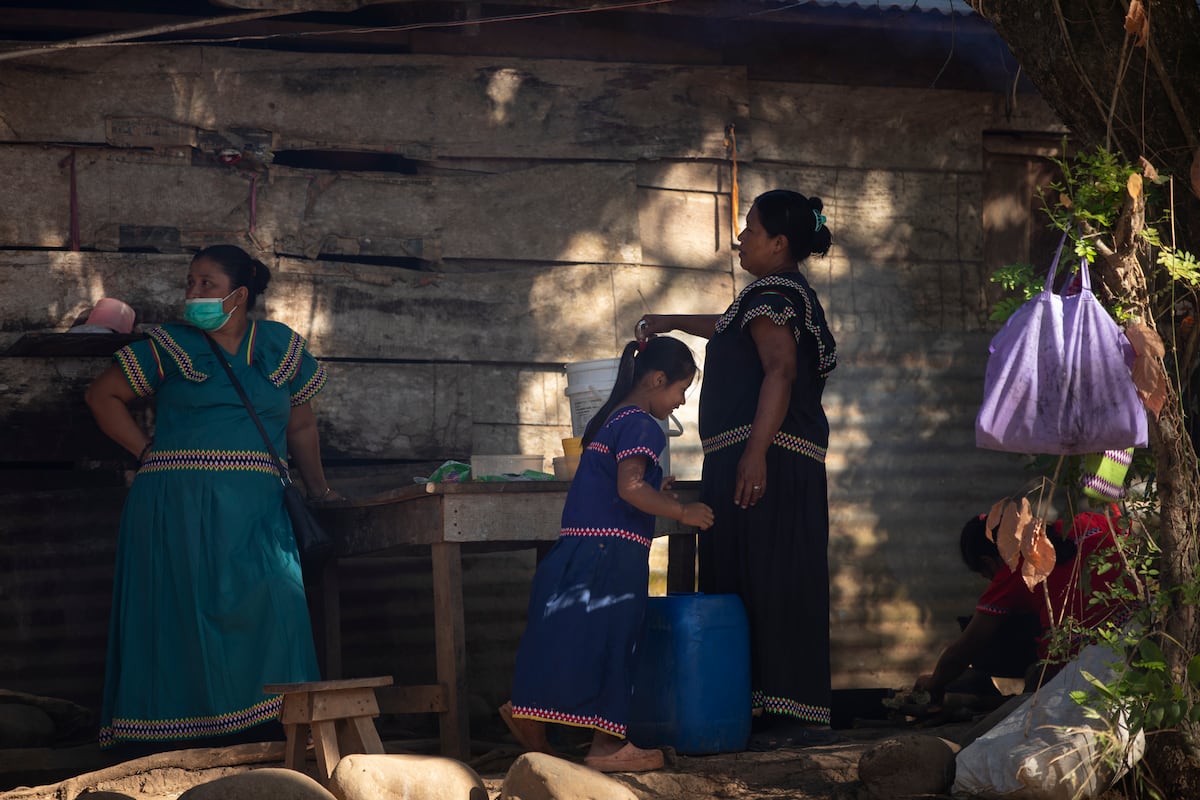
<box><xmin>626</xmin><ymin>594</ymin><xmax>751</xmax><ymax>754</ymax></box>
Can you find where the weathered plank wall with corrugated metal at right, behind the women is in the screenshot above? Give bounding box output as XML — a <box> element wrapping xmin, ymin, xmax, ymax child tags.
<box><xmin>0</xmin><ymin>35</ymin><xmax>1058</xmax><ymax>708</ymax></box>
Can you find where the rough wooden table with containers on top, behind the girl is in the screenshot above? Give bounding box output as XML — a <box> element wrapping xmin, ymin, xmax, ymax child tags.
<box><xmin>314</xmin><ymin>481</ymin><xmax>700</xmax><ymax>760</ymax></box>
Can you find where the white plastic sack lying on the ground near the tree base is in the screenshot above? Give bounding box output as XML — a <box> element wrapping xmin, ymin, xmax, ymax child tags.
<box><xmin>952</xmin><ymin>644</ymin><xmax>1146</xmax><ymax>800</ymax></box>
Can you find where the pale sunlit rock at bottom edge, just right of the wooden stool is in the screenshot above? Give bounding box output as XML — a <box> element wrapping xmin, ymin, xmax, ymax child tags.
<box><xmin>329</xmin><ymin>753</ymin><xmax>488</xmax><ymax>800</ymax></box>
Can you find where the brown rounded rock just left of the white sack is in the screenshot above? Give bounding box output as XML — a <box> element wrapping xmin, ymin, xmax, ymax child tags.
<box><xmin>858</xmin><ymin>734</ymin><xmax>961</xmax><ymax>800</ymax></box>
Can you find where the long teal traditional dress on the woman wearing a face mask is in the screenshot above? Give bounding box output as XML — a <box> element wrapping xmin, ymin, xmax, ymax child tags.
<box><xmin>100</xmin><ymin>321</ymin><xmax>325</xmax><ymax>747</ymax></box>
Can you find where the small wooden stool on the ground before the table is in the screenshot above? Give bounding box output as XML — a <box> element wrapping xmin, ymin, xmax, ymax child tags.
<box><xmin>263</xmin><ymin>676</ymin><xmax>391</xmax><ymax>786</ymax></box>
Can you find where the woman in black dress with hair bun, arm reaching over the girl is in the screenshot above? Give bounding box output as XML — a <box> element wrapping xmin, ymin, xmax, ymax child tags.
<box><xmin>637</xmin><ymin>190</ymin><xmax>838</xmax><ymax>750</ymax></box>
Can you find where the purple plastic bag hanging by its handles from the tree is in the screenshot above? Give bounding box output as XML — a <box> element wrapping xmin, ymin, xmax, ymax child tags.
<box><xmin>976</xmin><ymin>237</ymin><xmax>1146</xmax><ymax>455</ymax></box>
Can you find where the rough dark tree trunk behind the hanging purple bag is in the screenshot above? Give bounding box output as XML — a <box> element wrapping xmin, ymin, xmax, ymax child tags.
<box><xmin>968</xmin><ymin>0</ymin><xmax>1200</xmax><ymax>777</ymax></box>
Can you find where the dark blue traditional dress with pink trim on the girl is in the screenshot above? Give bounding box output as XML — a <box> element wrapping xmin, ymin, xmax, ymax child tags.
<box><xmin>512</xmin><ymin>405</ymin><xmax>666</xmax><ymax>738</ymax></box>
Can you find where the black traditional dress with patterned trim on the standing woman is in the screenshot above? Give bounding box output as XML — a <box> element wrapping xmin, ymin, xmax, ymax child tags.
<box><xmin>700</xmin><ymin>272</ymin><xmax>838</xmax><ymax>724</ymax></box>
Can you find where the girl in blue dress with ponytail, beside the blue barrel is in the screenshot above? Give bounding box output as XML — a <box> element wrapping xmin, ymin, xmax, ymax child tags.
<box><xmin>500</xmin><ymin>337</ymin><xmax>713</xmax><ymax>772</ymax></box>
